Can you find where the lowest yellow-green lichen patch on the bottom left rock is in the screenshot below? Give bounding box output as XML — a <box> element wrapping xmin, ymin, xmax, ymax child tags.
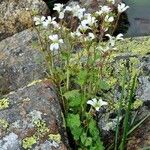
<box><xmin>22</xmin><ymin>135</ymin><xmax>36</xmax><ymax>149</ymax></box>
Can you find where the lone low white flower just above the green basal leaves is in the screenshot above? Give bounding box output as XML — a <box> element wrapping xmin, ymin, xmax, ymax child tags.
<box><xmin>87</xmin><ymin>98</ymin><xmax>108</xmax><ymax>111</ymax></box>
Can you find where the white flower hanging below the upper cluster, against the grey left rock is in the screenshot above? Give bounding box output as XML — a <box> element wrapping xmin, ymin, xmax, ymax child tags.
<box><xmin>49</xmin><ymin>34</ymin><xmax>64</xmax><ymax>51</ymax></box>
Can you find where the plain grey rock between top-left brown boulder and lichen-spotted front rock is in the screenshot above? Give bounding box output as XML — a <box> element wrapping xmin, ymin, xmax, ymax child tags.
<box><xmin>0</xmin><ymin>29</ymin><xmax>45</xmax><ymax>94</ymax></box>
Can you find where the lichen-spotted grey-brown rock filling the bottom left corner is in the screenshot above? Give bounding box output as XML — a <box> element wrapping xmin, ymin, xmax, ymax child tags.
<box><xmin>0</xmin><ymin>79</ymin><xmax>67</xmax><ymax>150</ymax></box>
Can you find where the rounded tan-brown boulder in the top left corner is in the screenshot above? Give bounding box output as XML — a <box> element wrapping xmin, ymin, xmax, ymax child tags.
<box><xmin>0</xmin><ymin>0</ymin><xmax>48</xmax><ymax>40</ymax></box>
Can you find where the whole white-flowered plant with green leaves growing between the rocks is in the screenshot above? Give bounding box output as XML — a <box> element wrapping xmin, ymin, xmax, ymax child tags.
<box><xmin>34</xmin><ymin>0</ymin><xmax>142</xmax><ymax>150</ymax></box>
